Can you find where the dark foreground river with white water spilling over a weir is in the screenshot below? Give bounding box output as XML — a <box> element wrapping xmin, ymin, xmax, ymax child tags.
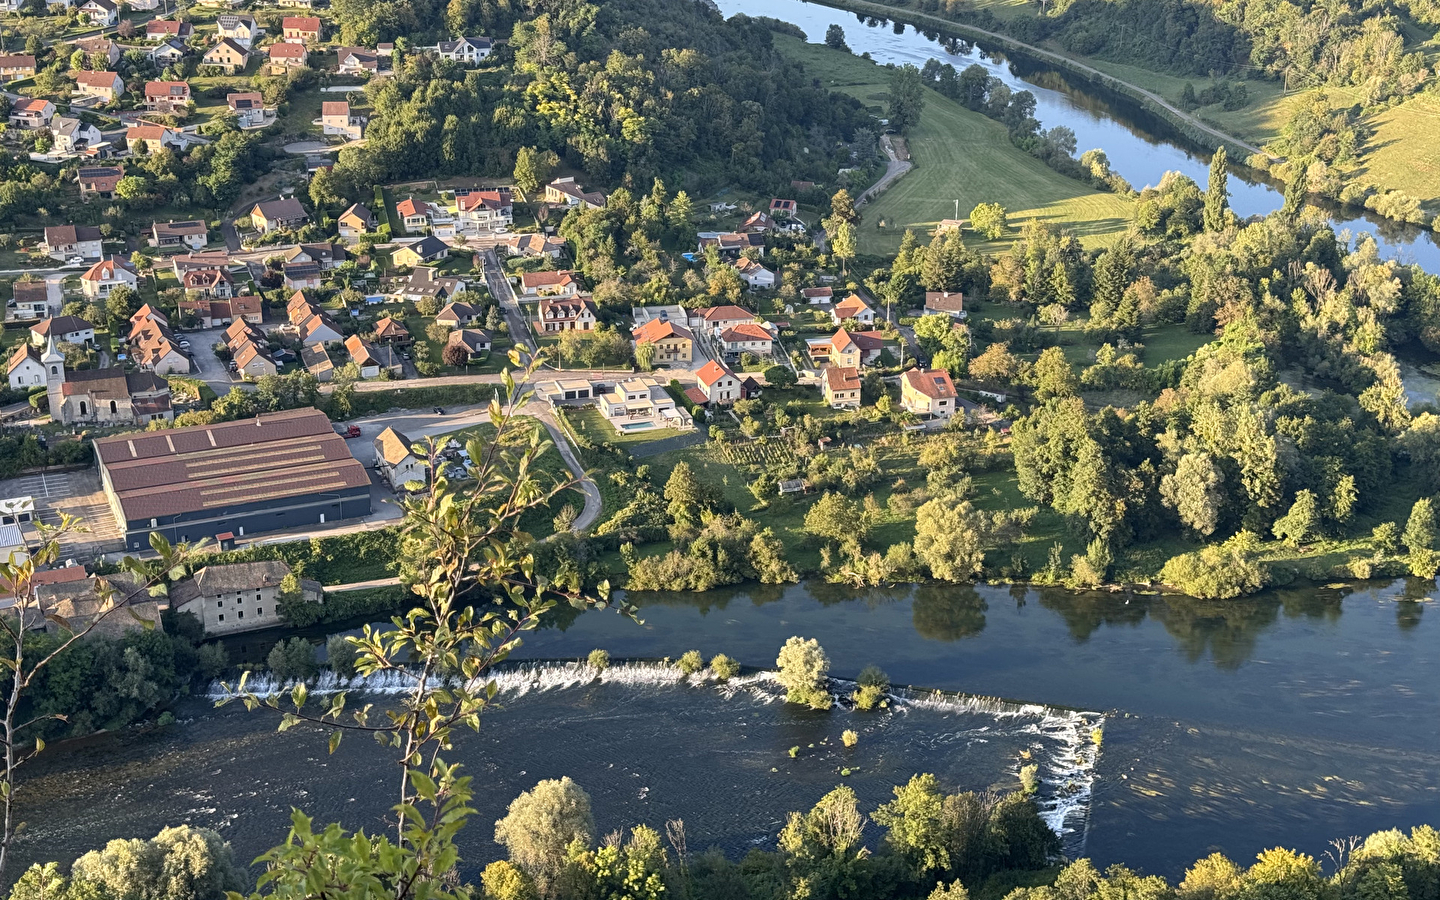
<box><xmin>20</xmin><ymin>582</ymin><xmax>1440</xmax><ymax>877</ymax></box>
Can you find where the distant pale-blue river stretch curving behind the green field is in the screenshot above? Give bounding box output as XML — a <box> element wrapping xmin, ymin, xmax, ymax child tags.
<box><xmin>714</xmin><ymin>0</ymin><xmax>1440</xmax><ymax>272</ymax></box>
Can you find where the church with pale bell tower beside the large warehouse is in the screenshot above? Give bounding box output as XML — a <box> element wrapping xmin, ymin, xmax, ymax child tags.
<box><xmin>40</xmin><ymin>337</ymin><xmax>174</xmax><ymax>426</ymax></box>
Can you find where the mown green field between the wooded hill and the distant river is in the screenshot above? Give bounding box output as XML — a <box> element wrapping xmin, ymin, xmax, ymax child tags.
<box><xmin>775</xmin><ymin>35</ymin><xmax>1133</xmax><ymax>253</ymax></box>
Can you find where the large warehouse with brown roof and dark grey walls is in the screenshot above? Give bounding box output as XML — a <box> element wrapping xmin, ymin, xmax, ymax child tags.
<box><xmin>95</xmin><ymin>409</ymin><xmax>370</xmax><ymax>550</ymax></box>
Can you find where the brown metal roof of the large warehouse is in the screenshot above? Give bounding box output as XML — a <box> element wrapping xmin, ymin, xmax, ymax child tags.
<box><xmin>95</xmin><ymin>409</ymin><xmax>370</xmax><ymax>521</ymax></box>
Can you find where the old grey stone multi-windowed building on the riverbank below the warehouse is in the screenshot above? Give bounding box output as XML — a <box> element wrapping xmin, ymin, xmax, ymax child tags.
<box><xmin>170</xmin><ymin>559</ymin><xmax>323</xmax><ymax>635</ymax></box>
